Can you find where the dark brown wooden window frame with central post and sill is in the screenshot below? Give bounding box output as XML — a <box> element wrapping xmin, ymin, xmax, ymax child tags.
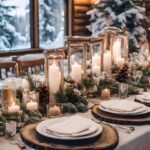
<box><xmin>0</xmin><ymin>0</ymin><xmax>69</xmax><ymax>57</ymax></box>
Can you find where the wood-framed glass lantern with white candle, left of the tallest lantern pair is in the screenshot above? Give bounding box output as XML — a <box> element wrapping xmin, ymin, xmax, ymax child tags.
<box><xmin>66</xmin><ymin>36</ymin><xmax>92</xmax><ymax>80</ymax></box>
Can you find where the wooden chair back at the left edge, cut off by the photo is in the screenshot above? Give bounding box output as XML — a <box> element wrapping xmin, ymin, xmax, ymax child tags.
<box><xmin>0</xmin><ymin>61</ymin><xmax>18</xmax><ymax>80</ymax></box>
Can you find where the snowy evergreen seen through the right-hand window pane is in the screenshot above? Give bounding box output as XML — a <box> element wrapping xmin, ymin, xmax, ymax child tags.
<box><xmin>39</xmin><ymin>0</ymin><xmax>62</xmax><ymax>42</ymax></box>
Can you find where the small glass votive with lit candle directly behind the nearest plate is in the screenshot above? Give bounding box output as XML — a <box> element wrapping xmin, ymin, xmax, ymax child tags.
<box><xmin>47</xmin><ymin>103</ymin><xmax>62</xmax><ymax>118</ymax></box>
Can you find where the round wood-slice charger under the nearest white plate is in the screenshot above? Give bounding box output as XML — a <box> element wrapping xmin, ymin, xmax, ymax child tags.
<box><xmin>20</xmin><ymin>124</ymin><xmax>119</xmax><ymax>150</ymax></box>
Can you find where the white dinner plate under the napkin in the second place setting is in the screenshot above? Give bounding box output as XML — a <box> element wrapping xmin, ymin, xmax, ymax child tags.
<box><xmin>99</xmin><ymin>100</ymin><xmax>150</xmax><ymax>115</ymax></box>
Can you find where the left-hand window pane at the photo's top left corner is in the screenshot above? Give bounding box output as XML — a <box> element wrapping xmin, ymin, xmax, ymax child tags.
<box><xmin>0</xmin><ymin>0</ymin><xmax>30</xmax><ymax>51</ymax></box>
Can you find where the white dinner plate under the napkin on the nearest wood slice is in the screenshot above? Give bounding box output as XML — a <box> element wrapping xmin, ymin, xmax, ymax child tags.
<box><xmin>36</xmin><ymin>117</ymin><xmax>103</xmax><ymax>140</ymax></box>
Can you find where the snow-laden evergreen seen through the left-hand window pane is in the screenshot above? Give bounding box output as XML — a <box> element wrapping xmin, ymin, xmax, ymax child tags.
<box><xmin>0</xmin><ymin>0</ymin><xmax>27</xmax><ymax>50</ymax></box>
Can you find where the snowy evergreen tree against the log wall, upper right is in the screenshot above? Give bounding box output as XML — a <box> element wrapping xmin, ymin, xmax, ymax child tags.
<box><xmin>87</xmin><ymin>0</ymin><xmax>149</xmax><ymax>52</ymax></box>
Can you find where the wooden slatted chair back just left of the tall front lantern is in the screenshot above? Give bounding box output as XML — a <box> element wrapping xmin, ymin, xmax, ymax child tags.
<box><xmin>18</xmin><ymin>58</ymin><xmax>44</xmax><ymax>76</ymax></box>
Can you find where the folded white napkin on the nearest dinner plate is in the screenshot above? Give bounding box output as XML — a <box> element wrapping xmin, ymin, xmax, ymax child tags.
<box><xmin>47</xmin><ymin>115</ymin><xmax>93</xmax><ymax>135</ymax></box>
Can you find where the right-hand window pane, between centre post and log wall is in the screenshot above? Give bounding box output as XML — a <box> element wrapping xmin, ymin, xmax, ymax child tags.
<box><xmin>39</xmin><ymin>0</ymin><xmax>64</xmax><ymax>48</ymax></box>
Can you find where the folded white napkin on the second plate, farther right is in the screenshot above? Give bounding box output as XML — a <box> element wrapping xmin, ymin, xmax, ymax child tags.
<box><xmin>100</xmin><ymin>100</ymin><xmax>142</xmax><ymax>112</ymax></box>
